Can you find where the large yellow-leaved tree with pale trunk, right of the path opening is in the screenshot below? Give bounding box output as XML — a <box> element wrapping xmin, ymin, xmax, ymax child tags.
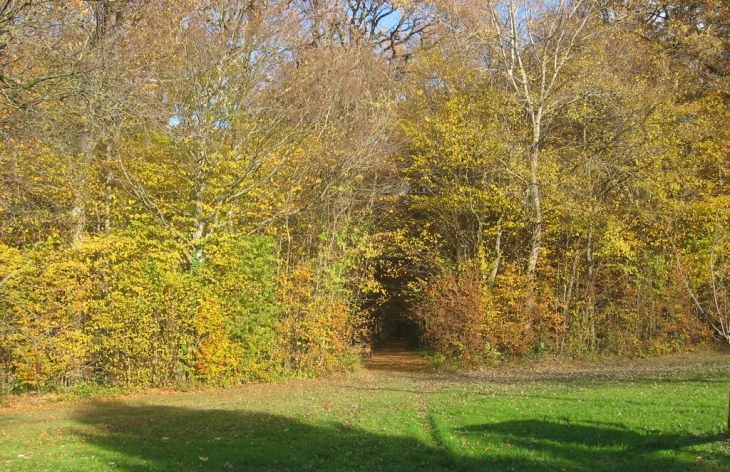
<box><xmin>396</xmin><ymin>3</ymin><xmax>712</xmax><ymax>358</ymax></box>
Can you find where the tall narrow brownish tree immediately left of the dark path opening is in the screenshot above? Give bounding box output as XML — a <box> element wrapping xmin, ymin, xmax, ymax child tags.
<box><xmin>270</xmin><ymin>5</ymin><xmax>416</xmax><ymax>364</ymax></box>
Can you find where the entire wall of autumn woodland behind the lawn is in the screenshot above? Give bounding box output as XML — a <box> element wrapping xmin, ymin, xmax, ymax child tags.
<box><xmin>0</xmin><ymin>0</ymin><xmax>730</xmax><ymax>393</ymax></box>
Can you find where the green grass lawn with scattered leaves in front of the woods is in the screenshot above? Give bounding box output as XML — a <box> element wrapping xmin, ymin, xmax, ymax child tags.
<box><xmin>0</xmin><ymin>354</ymin><xmax>730</xmax><ymax>472</ymax></box>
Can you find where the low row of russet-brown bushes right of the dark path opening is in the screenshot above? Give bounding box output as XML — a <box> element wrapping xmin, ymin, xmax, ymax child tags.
<box><xmin>412</xmin><ymin>264</ymin><xmax>711</xmax><ymax>366</ymax></box>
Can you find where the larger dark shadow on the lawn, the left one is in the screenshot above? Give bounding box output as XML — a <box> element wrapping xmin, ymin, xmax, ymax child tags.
<box><xmin>75</xmin><ymin>402</ymin><xmax>455</xmax><ymax>472</ymax></box>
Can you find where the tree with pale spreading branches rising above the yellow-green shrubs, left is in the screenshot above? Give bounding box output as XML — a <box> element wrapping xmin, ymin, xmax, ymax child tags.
<box><xmin>119</xmin><ymin>2</ymin><xmax>300</xmax><ymax>265</ymax></box>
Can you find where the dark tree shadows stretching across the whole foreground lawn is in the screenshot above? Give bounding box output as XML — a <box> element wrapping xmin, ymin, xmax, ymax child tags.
<box><xmin>75</xmin><ymin>402</ymin><xmax>717</xmax><ymax>472</ymax></box>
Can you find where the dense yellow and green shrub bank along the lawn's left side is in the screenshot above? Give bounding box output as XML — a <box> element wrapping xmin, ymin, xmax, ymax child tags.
<box><xmin>1</xmin><ymin>234</ymin><xmax>298</xmax><ymax>389</ymax></box>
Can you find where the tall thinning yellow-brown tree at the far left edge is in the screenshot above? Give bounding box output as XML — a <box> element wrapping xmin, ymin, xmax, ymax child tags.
<box><xmin>4</xmin><ymin>1</ymin><xmax>149</xmax><ymax>247</ymax></box>
